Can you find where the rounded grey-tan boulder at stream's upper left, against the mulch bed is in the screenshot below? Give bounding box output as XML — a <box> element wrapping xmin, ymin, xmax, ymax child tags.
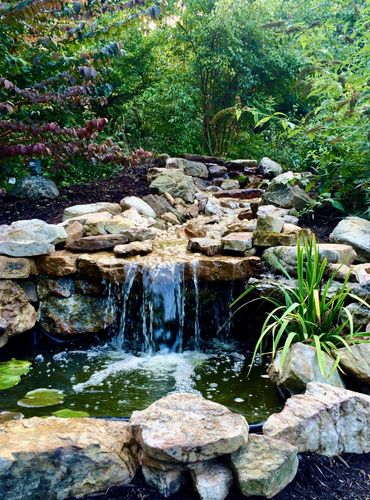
<box><xmin>150</xmin><ymin>170</ymin><xmax>196</xmax><ymax>203</ymax></box>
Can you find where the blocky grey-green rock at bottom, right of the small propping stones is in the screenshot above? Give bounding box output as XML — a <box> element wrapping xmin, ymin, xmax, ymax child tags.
<box><xmin>231</xmin><ymin>434</ymin><xmax>298</xmax><ymax>498</ymax></box>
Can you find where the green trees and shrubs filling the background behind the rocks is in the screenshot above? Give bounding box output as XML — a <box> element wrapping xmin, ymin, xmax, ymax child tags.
<box><xmin>0</xmin><ymin>0</ymin><xmax>370</xmax><ymax>214</ymax></box>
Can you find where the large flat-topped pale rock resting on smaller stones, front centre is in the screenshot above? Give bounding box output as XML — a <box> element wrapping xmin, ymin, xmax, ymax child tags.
<box><xmin>130</xmin><ymin>393</ymin><xmax>248</xmax><ymax>463</ymax></box>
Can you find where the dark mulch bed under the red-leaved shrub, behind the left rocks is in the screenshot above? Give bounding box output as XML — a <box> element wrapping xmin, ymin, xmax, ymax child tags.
<box><xmin>0</xmin><ymin>166</ymin><xmax>149</xmax><ymax>224</ymax></box>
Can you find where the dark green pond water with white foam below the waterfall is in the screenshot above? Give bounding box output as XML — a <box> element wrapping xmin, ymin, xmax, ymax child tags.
<box><xmin>0</xmin><ymin>341</ymin><xmax>282</xmax><ymax>423</ymax></box>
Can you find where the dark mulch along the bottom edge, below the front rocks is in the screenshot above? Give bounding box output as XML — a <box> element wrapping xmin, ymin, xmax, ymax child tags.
<box><xmin>86</xmin><ymin>454</ymin><xmax>370</xmax><ymax>500</ymax></box>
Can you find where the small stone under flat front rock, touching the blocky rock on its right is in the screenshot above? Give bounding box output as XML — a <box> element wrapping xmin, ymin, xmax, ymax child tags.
<box><xmin>191</xmin><ymin>459</ymin><xmax>234</xmax><ymax>500</ymax></box>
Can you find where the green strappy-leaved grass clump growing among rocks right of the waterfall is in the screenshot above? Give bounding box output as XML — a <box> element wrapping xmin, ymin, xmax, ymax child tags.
<box><xmin>233</xmin><ymin>237</ymin><xmax>370</xmax><ymax>377</ymax></box>
